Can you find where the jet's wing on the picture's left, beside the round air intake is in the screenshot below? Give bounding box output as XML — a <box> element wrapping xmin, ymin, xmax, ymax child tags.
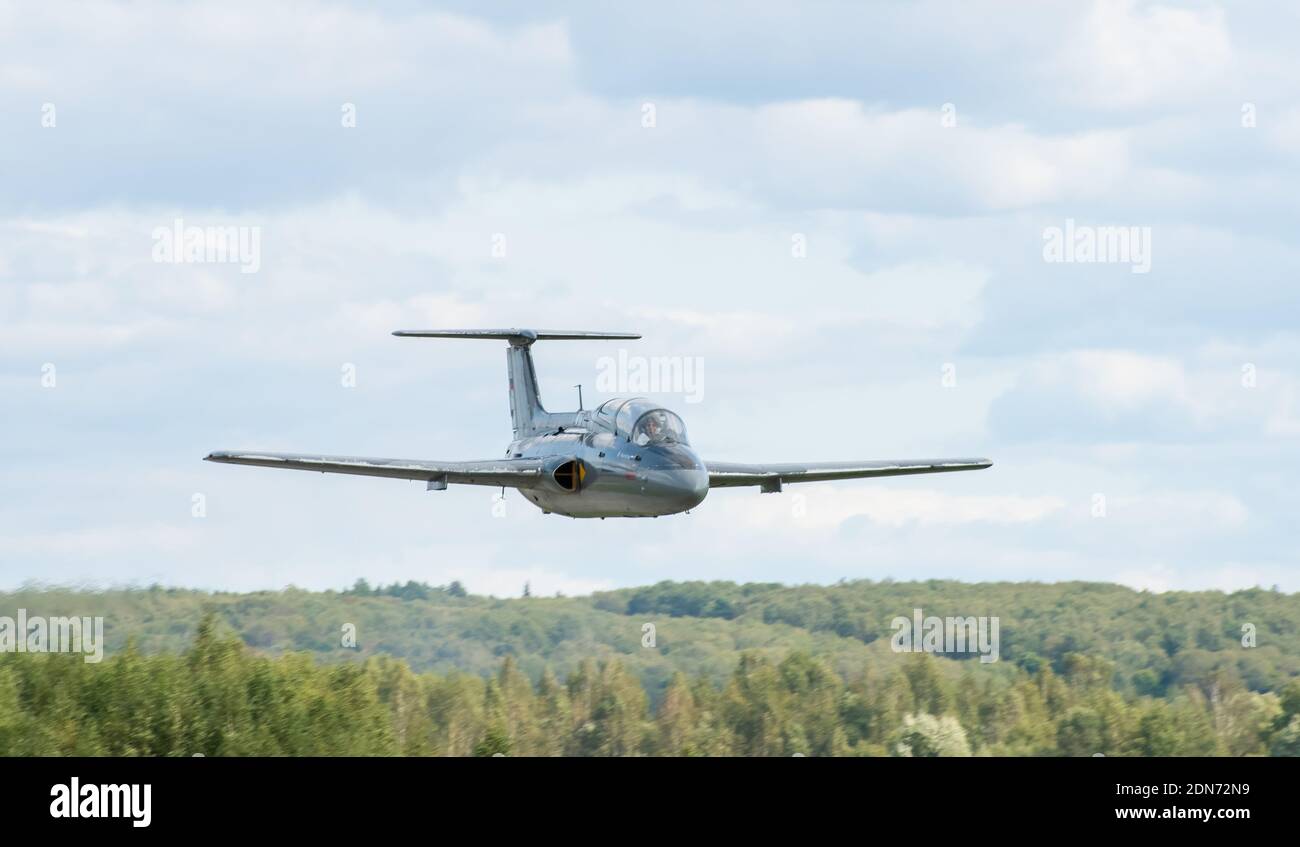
<box><xmin>204</xmin><ymin>449</ymin><xmax>542</xmax><ymax>488</ymax></box>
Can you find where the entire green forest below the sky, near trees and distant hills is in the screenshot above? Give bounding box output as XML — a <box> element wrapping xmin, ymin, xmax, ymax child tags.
<box><xmin>0</xmin><ymin>582</ymin><xmax>1300</xmax><ymax>756</ymax></box>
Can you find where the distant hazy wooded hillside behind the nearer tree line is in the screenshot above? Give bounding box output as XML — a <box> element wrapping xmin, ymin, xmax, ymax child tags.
<box><xmin>0</xmin><ymin>581</ymin><xmax>1300</xmax><ymax>700</ymax></box>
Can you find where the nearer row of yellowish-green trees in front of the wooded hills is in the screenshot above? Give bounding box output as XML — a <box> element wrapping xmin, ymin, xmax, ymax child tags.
<box><xmin>0</xmin><ymin>616</ymin><xmax>1300</xmax><ymax>756</ymax></box>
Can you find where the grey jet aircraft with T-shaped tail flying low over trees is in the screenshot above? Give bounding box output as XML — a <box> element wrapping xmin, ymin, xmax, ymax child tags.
<box><xmin>205</xmin><ymin>329</ymin><xmax>993</xmax><ymax>518</ymax></box>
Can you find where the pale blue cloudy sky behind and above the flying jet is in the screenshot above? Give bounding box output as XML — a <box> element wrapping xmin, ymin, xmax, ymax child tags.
<box><xmin>0</xmin><ymin>0</ymin><xmax>1300</xmax><ymax>595</ymax></box>
